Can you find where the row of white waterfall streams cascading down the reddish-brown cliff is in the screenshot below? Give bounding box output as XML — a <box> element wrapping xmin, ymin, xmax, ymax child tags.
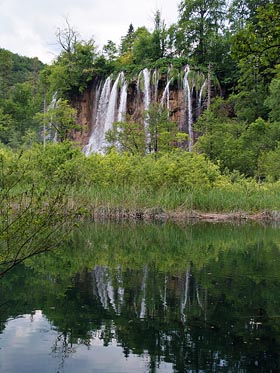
<box><xmin>84</xmin><ymin>65</ymin><xmax>212</xmax><ymax>155</ymax></box>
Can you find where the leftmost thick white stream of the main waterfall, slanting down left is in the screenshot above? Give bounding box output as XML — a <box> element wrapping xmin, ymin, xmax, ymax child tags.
<box><xmin>84</xmin><ymin>77</ymin><xmax>111</xmax><ymax>155</ymax></box>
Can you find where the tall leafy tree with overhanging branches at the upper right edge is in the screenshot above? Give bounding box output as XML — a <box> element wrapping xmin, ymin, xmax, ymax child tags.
<box><xmin>232</xmin><ymin>3</ymin><xmax>280</xmax><ymax>122</ymax></box>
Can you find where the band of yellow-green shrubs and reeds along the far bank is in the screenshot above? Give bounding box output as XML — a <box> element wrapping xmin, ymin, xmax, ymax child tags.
<box><xmin>3</xmin><ymin>143</ymin><xmax>280</xmax><ymax>215</ymax></box>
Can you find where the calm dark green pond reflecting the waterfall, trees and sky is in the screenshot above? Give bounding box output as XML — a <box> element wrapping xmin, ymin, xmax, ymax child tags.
<box><xmin>0</xmin><ymin>223</ymin><xmax>280</xmax><ymax>373</ymax></box>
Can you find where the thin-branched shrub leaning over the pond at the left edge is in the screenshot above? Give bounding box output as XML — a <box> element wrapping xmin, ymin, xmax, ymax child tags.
<box><xmin>0</xmin><ymin>151</ymin><xmax>74</xmax><ymax>276</ymax></box>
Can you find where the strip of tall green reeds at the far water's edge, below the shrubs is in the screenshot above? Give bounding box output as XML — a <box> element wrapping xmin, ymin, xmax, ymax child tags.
<box><xmin>72</xmin><ymin>184</ymin><xmax>280</xmax><ymax>213</ymax></box>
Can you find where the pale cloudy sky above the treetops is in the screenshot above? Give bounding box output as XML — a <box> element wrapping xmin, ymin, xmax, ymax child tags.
<box><xmin>0</xmin><ymin>0</ymin><xmax>179</xmax><ymax>63</ymax></box>
